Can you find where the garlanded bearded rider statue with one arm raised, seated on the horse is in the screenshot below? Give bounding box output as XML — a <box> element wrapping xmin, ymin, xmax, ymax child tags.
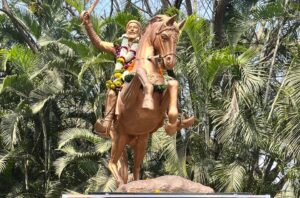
<box><xmin>80</xmin><ymin>11</ymin><xmax>142</xmax><ymax>136</ymax></box>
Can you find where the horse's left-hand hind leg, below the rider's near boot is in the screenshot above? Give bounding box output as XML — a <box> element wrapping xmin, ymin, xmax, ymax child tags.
<box><xmin>108</xmin><ymin>133</ymin><xmax>128</xmax><ymax>185</ymax></box>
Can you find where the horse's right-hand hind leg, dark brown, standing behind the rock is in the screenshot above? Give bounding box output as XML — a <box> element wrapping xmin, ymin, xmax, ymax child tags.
<box><xmin>133</xmin><ymin>134</ymin><xmax>149</xmax><ymax>180</ymax></box>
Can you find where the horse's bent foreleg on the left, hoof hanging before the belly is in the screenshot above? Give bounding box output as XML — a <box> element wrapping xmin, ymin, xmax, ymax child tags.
<box><xmin>136</xmin><ymin>67</ymin><xmax>154</xmax><ymax>110</ymax></box>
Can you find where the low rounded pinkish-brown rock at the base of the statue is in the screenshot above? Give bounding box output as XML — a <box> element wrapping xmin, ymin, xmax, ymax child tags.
<box><xmin>117</xmin><ymin>175</ymin><xmax>214</xmax><ymax>193</ymax></box>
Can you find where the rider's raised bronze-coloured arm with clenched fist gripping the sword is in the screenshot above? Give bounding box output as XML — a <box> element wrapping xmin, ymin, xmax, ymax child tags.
<box><xmin>80</xmin><ymin>11</ymin><xmax>116</xmax><ymax>54</ymax></box>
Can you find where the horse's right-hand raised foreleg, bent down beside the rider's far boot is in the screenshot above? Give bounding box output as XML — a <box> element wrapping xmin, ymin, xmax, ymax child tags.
<box><xmin>165</xmin><ymin>80</ymin><xmax>179</xmax><ymax>135</ymax></box>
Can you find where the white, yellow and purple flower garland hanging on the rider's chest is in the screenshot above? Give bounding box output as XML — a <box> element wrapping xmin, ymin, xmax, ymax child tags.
<box><xmin>106</xmin><ymin>34</ymin><xmax>139</xmax><ymax>89</ymax></box>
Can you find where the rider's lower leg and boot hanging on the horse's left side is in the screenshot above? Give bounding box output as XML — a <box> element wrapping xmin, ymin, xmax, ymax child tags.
<box><xmin>95</xmin><ymin>90</ymin><xmax>117</xmax><ymax>137</ymax></box>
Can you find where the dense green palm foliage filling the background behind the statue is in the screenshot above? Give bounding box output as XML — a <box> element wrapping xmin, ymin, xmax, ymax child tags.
<box><xmin>0</xmin><ymin>0</ymin><xmax>300</xmax><ymax>197</ymax></box>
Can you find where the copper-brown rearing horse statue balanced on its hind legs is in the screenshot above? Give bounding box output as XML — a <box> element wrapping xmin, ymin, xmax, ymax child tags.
<box><xmin>98</xmin><ymin>15</ymin><xmax>194</xmax><ymax>185</ymax></box>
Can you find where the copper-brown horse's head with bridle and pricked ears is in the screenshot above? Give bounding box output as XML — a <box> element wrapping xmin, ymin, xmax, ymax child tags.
<box><xmin>151</xmin><ymin>15</ymin><xmax>185</xmax><ymax>69</ymax></box>
